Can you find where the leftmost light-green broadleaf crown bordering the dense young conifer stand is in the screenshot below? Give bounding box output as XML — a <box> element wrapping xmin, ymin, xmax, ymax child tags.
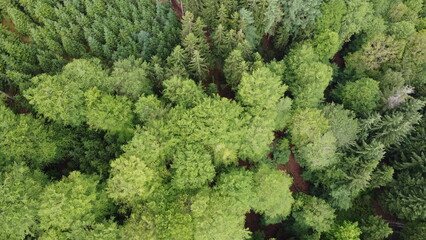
<box><xmin>24</xmin><ymin>59</ymin><xmax>107</xmax><ymax>126</ymax></box>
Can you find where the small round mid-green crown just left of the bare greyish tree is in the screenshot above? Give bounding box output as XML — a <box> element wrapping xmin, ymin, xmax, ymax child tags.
<box><xmin>340</xmin><ymin>78</ymin><xmax>379</xmax><ymax>115</ymax></box>
